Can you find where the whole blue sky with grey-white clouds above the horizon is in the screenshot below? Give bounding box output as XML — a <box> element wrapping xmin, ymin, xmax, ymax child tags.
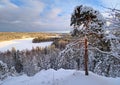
<box><xmin>0</xmin><ymin>0</ymin><xmax>120</xmax><ymax>32</ymax></box>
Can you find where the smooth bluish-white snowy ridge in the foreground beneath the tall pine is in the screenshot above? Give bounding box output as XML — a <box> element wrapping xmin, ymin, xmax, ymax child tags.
<box><xmin>0</xmin><ymin>69</ymin><xmax>120</xmax><ymax>85</ymax></box>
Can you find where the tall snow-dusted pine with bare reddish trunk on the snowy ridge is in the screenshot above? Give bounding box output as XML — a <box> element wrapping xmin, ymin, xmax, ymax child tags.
<box><xmin>70</xmin><ymin>5</ymin><xmax>105</xmax><ymax>75</ymax></box>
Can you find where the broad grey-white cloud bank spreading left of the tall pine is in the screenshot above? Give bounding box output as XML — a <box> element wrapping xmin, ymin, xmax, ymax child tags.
<box><xmin>0</xmin><ymin>0</ymin><xmax>70</xmax><ymax>31</ymax></box>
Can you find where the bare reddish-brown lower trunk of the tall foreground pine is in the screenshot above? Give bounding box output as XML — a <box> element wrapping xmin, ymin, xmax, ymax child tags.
<box><xmin>84</xmin><ymin>36</ymin><xmax>88</xmax><ymax>75</ymax></box>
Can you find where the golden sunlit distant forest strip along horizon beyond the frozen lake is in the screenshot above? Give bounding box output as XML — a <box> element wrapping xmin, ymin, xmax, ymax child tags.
<box><xmin>0</xmin><ymin>32</ymin><xmax>59</xmax><ymax>41</ymax></box>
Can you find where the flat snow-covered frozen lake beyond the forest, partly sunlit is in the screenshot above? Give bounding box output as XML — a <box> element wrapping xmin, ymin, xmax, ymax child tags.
<box><xmin>0</xmin><ymin>38</ymin><xmax>52</xmax><ymax>52</ymax></box>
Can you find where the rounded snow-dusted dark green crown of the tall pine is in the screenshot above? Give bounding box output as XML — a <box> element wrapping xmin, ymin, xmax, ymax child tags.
<box><xmin>71</xmin><ymin>5</ymin><xmax>106</xmax><ymax>33</ymax></box>
